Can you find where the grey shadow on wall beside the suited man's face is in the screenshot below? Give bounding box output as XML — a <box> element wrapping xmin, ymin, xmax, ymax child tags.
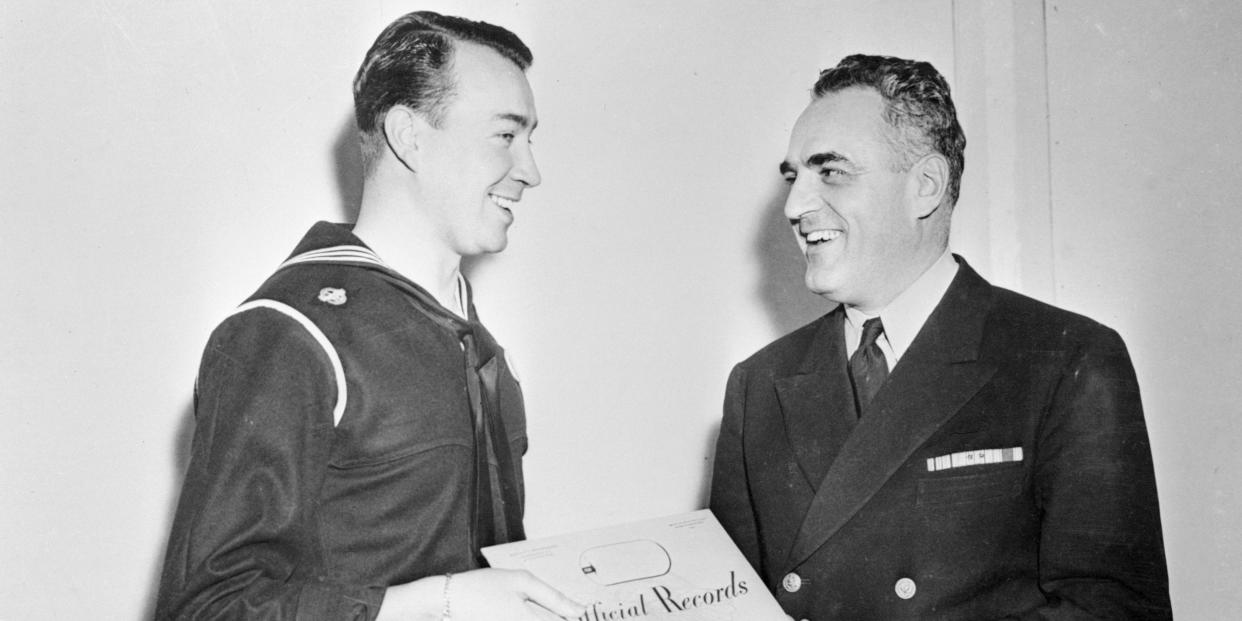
<box><xmin>754</xmin><ymin>183</ymin><xmax>836</xmax><ymax>335</ymax></box>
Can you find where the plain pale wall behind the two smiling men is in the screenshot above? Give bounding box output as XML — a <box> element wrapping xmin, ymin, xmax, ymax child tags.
<box><xmin>0</xmin><ymin>0</ymin><xmax>1242</xmax><ymax>620</ymax></box>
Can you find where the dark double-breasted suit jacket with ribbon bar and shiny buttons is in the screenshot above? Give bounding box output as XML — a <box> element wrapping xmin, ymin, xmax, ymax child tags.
<box><xmin>710</xmin><ymin>257</ymin><xmax>1171</xmax><ymax>621</ymax></box>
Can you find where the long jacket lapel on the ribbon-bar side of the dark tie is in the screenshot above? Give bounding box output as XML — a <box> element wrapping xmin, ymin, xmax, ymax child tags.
<box><xmin>787</xmin><ymin>261</ymin><xmax>996</xmax><ymax>568</ymax></box>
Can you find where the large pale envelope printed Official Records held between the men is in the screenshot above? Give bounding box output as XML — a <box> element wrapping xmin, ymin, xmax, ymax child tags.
<box><xmin>483</xmin><ymin>509</ymin><xmax>786</xmax><ymax>621</ymax></box>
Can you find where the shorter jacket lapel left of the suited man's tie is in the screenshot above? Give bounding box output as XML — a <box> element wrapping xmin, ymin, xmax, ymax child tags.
<box><xmin>775</xmin><ymin>307</ymin><xmax>858</xmax><ymax>491</ymax></box>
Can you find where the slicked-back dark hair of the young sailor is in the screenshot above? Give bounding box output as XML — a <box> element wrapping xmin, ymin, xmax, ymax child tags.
<box><xmin>354</xmin><ymin>11</ymin><xmax>534</xmax><ymax>175</ymax></box>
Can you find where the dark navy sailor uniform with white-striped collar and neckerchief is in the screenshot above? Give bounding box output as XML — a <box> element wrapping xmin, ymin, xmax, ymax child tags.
<box><xmin>156</xmin><ymin>222</ymin><xmax>527</xmax><ymax>621</ymax></box>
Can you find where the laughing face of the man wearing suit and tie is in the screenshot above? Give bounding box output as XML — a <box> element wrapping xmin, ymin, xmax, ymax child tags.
<box><xmin>780</xmin><ymin>87</ymin><xmax>929</xmax><ymax>311</ymax></box>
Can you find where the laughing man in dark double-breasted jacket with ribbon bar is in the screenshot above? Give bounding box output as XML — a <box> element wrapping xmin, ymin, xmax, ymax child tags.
<box><xmin>712</xmin><ymin>56</ymin><xmax>1171</xmax><ymax>621</ymax></box>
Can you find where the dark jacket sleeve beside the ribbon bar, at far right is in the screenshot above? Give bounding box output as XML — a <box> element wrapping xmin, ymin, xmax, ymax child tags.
<box><xmin>1022</xmin><ymin>328</ymin><xmax>1172</xmax><ymax>620</ymax></box>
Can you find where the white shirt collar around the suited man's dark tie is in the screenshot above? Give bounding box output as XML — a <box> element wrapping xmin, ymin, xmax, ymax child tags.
<box><xmin>846</xmin><ymin>250</ymin><xmax>958</xmax><ymax>369</ymax></box>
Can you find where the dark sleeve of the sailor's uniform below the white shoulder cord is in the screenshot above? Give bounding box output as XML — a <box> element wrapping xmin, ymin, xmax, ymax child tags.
<box><xmin>155</xmin><ymin>308</ymin><xmax>384</xmax><ymax>621</ymax></box>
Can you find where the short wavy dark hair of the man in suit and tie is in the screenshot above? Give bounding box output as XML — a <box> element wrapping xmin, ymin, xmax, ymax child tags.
<box><xmin>814</xmin><ymin>53</ymin><xmax>966</xmax><ymax>206</ymax></box>
